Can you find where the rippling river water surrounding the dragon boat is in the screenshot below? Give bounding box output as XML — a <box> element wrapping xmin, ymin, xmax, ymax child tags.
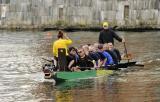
<box><xmin>0</xmin><ymin>31</ymin><xmax>160</xmax><ymax>102</ymax></box>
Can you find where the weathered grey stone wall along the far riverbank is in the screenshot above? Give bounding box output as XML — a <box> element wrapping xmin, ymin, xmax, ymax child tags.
<box><xmin>0</xmin><ymin>0</ymin><xmax>160</xmax><ymax>30</ymax></box>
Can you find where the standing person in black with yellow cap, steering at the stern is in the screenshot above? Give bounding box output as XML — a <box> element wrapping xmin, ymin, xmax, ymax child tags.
<box><xmin>99</xmin><ymin>22</ymin><xmax>125</xmax><ymax>45</ymax></box>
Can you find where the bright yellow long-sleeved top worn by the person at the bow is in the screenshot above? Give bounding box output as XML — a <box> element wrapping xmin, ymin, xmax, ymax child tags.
<box><xmin>53</xmin><ymin>39</ymin><xmax>72</xmax><ymax>57</ymax></box>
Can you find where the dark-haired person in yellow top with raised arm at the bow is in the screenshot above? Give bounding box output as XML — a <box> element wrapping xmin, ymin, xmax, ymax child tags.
<box><xmin>53</xmin><ymin>31</ymin><xmax>72</xmax><ymax>57</ymax></box>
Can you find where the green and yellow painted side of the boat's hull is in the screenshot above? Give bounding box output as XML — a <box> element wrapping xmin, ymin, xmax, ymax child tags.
<box><xmin>54</xmin><ymin>70</ymin><xmax>113</xmax><ymax>81</ymax></box>
